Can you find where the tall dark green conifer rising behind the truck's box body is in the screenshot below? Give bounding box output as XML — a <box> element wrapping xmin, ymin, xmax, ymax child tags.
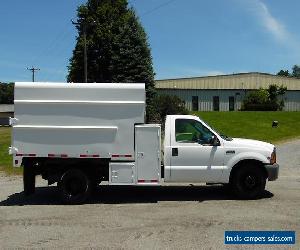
<box><xmin>67</xmin><ymin>0</ymin><xmax>156</xmax><ymax>120</ymax></box>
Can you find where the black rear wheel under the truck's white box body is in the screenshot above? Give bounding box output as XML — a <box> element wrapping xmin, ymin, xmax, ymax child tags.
<box><xmin>58</xmin><ymin>169</ymin><xmax>93</xmax><ymax>205</ymax></box>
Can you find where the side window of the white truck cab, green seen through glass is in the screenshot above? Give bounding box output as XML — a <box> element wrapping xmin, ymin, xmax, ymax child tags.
<box><xmin>175</xmin><ymin>119</ymin><xmax>213</xmax><ymax>145</ymax></box>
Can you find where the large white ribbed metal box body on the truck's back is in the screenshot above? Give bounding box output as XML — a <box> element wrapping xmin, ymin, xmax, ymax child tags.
<box><xmin>10</xmin><ymin>82</ymin><xmax>145</xmax><ymax>165</ymax></box>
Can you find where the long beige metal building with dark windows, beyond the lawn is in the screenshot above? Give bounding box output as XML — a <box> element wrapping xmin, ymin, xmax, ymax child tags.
<box><xmin>155</xmin><ymin>72</ymin><xmax>300</xmax><ymax>111</ymax></box>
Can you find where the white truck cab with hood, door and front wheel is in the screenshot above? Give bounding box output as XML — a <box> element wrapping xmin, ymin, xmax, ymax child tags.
<box><xmin>164</xmin><ymin>115</ymin><xmax>279</xmax><ymax>198</ymax></box>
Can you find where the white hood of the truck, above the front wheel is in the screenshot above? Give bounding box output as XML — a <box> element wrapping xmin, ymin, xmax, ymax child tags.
<box><xmin>225</xmin><ymin>138</ymin><xmax>274</xmax><ymax>152</ymax></box>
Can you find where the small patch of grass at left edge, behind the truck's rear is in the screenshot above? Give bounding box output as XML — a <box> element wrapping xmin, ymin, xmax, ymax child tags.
<box><xmin>0</xmin><ymin>127</ymin><xmax>22</xmax><ymax>175</ymax></box>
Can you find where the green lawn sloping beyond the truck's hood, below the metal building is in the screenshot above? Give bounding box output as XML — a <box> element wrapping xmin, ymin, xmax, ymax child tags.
<box><xmin>193</xmin><ymin>111</ymin><xmax>300</xmax><ymax>143</ymax></box>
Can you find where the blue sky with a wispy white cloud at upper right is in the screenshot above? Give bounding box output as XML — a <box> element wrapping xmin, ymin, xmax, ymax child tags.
<box><xmin>0</xmin><ymin>0</ymin><xmax>300</xmax><ymax>82</ymax></box>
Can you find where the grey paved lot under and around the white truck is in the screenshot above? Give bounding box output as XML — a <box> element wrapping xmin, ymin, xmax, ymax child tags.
<box><xmin>0</xmin><ymin>140</ymin><xmax>300</xmax><ymax>249</ymax></box>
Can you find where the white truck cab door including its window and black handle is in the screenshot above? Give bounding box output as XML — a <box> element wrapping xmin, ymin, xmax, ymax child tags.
<box><xmin>170</xmin><ymin>118</ymin><xmax>224</xmax><ymax>182</ymax></box>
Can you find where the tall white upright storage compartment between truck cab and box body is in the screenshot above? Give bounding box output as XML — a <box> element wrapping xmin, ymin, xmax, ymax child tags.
<box><xmin>135</xmin><ymin>124</ymin><xmax>161</xmax><ymax>184</ymax></box>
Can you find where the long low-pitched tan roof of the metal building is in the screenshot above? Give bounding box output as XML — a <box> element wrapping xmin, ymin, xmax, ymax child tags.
<box><xmin>155</xmin><ymin>72</ymin><xmax>300</xmax><ymax>90</ymax></box>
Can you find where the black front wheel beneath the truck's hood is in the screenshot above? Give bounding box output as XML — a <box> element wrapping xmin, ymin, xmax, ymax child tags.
<box><xmin>231</xmin><ymin>165</ymin><xmax>266</xmax><ymax>199</ymax></box>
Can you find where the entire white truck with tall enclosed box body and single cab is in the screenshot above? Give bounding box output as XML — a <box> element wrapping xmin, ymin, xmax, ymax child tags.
<box><xmin>9</xmin><ymin>82</ymin><xmax>279</xmax><ymax>204</ymax></box>
